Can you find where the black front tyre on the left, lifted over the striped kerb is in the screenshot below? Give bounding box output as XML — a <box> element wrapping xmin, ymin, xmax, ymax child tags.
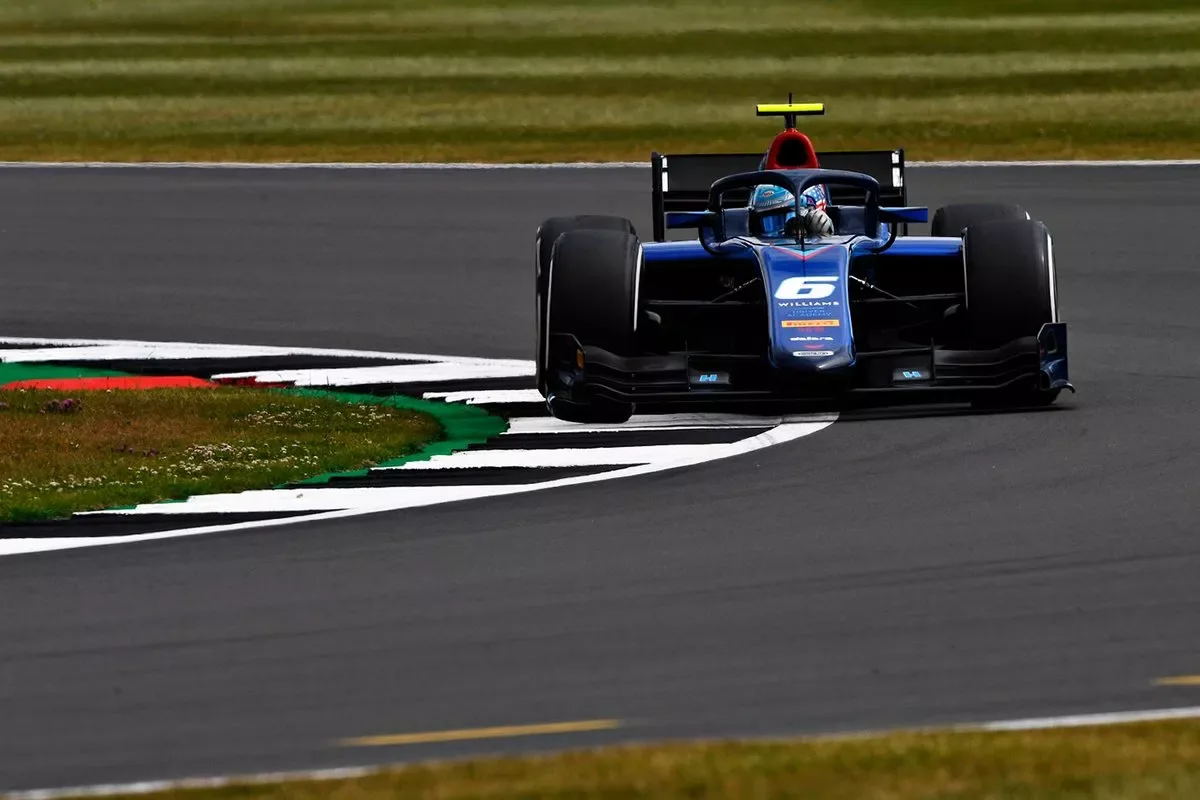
<box><xmin>541</xmin><ymin>230</ymin><xmax>642</xmax><ymax>422</ymax></box>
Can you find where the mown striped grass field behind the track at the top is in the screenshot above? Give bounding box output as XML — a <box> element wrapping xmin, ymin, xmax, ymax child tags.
<box><xmin>0</xmin><ymin>0</ymin><xmax>1200</xmax><ymax>161</ymax></box>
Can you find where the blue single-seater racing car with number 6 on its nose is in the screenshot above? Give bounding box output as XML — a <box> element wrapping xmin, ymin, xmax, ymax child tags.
<box><xmin>535</xmin><ymin>101</ymin><xmax>1074</xmax><ymax>423</ymax></box>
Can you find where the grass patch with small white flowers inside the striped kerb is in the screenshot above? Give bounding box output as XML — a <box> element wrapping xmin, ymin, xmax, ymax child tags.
<box><xmin>0</xmin><ymin>386</ymin><xmax>440</xmax><ymax>522</ymax></box>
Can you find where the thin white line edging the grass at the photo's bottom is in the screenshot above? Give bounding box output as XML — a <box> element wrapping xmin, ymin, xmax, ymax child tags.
<box><xmin>4</xmin><ymin>706</ymin><xmax>1200</xmax><ymax>800</ymax></box>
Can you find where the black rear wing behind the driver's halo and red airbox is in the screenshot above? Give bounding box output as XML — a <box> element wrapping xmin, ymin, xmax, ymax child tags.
<box><xmin>650</xmin><ymin>149</ymin><xmax>908</xmax><ymax>241</ymax></box>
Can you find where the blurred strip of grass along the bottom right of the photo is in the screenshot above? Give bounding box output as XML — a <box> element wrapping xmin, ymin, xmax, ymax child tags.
<box><xmin>68</xmin><ymin>721</ymin><xmax>1200</xmax><ymax>800</ymax></box>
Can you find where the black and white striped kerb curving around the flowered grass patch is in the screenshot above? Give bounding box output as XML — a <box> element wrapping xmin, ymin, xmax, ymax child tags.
<box><xmin>0</xmin><ymin>338</ymin><xmax>838</xmax><ymax>555</ymax></box>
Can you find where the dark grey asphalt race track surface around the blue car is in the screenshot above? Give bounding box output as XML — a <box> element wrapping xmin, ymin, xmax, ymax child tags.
<box><xmin>0</xmin><ymin>168</ymin><xmax>1200</xmax><ymax>788</ymax></box>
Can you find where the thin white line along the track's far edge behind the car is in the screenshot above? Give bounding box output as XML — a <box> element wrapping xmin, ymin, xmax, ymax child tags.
<box><xmin>0</xmin><ymin>158</ymin><xmax>1200</xmax><ymax>170</ymax></box>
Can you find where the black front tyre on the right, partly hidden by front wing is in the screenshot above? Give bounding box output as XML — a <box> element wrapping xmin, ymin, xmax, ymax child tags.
<box><xmin>962</xmin><ymin>219</ymin><xmax>1058</xmax><ymax>408</ymax></box>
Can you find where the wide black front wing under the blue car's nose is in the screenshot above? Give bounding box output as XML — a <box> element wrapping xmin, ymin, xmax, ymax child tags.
<box><xmin>547</xmin><ymin>323</ymin><xmax>1074</xmax><ymax>409</ymax></box>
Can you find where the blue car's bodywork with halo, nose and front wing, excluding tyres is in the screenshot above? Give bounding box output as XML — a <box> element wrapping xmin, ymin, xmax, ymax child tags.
<box><xmin>546</xmin><ymin>161</ymin><xmax>1074</xmax><ymax>416</ymax></box>
